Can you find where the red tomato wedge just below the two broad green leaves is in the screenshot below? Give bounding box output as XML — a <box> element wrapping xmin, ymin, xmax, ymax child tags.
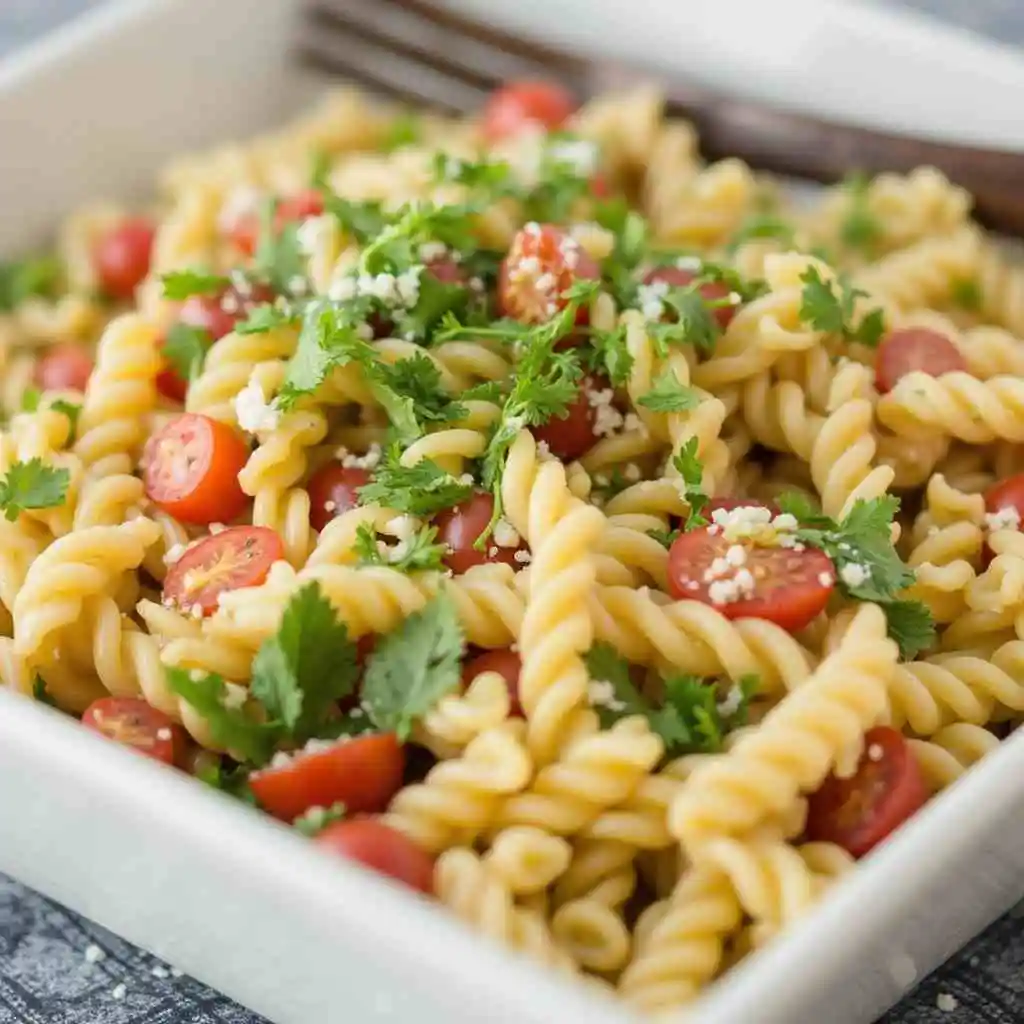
<box><xmin>249</xmin><ymin>732</ymin><xmax>406</xmax><ymax>821</ymax></box>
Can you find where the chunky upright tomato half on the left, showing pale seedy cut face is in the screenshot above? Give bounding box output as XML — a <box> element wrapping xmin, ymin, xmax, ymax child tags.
<box><xmin>142</xmin><ymin>413</ymin><xmax>249</xmax><ymax>523</ymax></box>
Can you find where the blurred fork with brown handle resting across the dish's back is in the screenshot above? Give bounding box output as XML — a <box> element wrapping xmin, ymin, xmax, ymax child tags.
<box><xmin>298</xmin><ymin>0</ymin><xmax>1024</xmax><ymax>234</ymax></box>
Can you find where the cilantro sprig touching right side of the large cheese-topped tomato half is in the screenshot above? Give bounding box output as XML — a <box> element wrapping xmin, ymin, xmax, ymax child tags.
<box><xmin>778</xmin><ymin>494</ymin><xmax>935</xmax><ymax>658</ymax></box>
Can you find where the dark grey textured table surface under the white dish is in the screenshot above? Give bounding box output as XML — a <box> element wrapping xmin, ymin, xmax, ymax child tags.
<box><xmin>0</xmin><ymin>0</ymin><xmax>1024</xmax><ymax>1024</ymax></box>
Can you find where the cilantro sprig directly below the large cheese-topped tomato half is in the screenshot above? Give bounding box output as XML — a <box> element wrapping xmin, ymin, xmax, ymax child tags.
<box><xmin>586</xmin><ymin>643</ymin><xmax>759</xmax><ymax>758</ymax></box>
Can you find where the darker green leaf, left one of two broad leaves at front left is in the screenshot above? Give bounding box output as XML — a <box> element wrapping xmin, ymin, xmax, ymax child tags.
<box><xmin>250</xmin><ymin>581</ymin><xmax>358</xmax><ymax>742</ymax></box>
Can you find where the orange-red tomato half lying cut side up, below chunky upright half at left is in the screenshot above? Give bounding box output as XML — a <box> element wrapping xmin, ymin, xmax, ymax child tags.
<box><xmin>164</xmin><ymin>526</ymin><xmax>285</xmax><ymax>614</ymax></box>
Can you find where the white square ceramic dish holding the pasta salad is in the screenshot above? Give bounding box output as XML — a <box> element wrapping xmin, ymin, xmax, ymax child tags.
<box><xmin>0</xmin><ymin>0</ymin><xmax>1024</xmax><ymax>1024</ymax></box>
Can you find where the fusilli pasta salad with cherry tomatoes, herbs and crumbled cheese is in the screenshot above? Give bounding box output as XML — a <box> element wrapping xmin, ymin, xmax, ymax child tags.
<box><xmin>0</xmin><ymin>82</ymin><xmax>1024</xmax><ymax>1012</ymax></box>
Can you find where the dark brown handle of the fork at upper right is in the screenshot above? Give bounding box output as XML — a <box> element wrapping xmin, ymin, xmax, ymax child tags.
<box><xmin>672</xmin><ymin>96</ymin><xmax>1024</xmax><ymax>234</ymax></box>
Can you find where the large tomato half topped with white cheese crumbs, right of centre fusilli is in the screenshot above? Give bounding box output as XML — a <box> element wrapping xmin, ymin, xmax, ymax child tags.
<box><xmin>669</xmin><ymin>527</ymin><xmax>836</xmax><ymax>633</ymax></box>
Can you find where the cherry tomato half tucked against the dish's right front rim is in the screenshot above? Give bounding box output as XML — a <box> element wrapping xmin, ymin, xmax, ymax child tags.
<box><xmin>807</xmin><ymin>725</ymin><xmax>928</xmax><ymax>857</ymax></box>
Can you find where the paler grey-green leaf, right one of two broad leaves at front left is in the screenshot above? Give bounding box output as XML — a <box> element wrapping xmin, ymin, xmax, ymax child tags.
<box><xmin>362</xmin><ymin>592</ymin><xmax>464</xmax><ymax>740</ymax></box>
